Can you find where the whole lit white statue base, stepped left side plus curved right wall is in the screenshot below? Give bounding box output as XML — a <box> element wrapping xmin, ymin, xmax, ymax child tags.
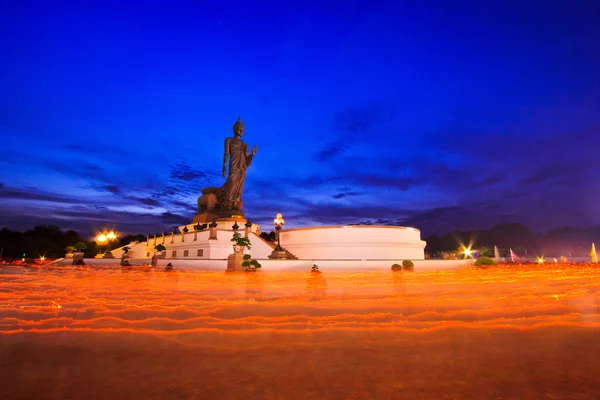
<box><xmin>112</xmin><ymin>225</ymin><xmax>425</xmax><ymax>261</ymax></box>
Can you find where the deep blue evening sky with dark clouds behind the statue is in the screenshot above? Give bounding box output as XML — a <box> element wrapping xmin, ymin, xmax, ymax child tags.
<box><xmin>0</xmin><ymin>0</ymin><xmax>600</xmax><ymax>235</ymax></box>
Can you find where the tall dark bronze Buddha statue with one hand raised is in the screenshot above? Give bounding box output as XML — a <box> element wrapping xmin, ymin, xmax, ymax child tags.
<box><xmin>194</xmin><ymin>117</ymin><xmax>258</xmax><ymax>223</ymax></box>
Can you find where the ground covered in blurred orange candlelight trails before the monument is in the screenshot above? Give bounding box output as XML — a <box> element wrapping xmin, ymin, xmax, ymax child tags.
<box><xmin>0</xmin><ymin>265</ymin><xmax>600</xmax><ymax>399</ymax></box>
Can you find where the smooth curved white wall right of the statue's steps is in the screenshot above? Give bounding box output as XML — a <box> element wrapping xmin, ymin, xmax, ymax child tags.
<box><xmin>281</xmin><ymin>225</ymin><xmax>425</xmax><ymax>260</ymax></box>
